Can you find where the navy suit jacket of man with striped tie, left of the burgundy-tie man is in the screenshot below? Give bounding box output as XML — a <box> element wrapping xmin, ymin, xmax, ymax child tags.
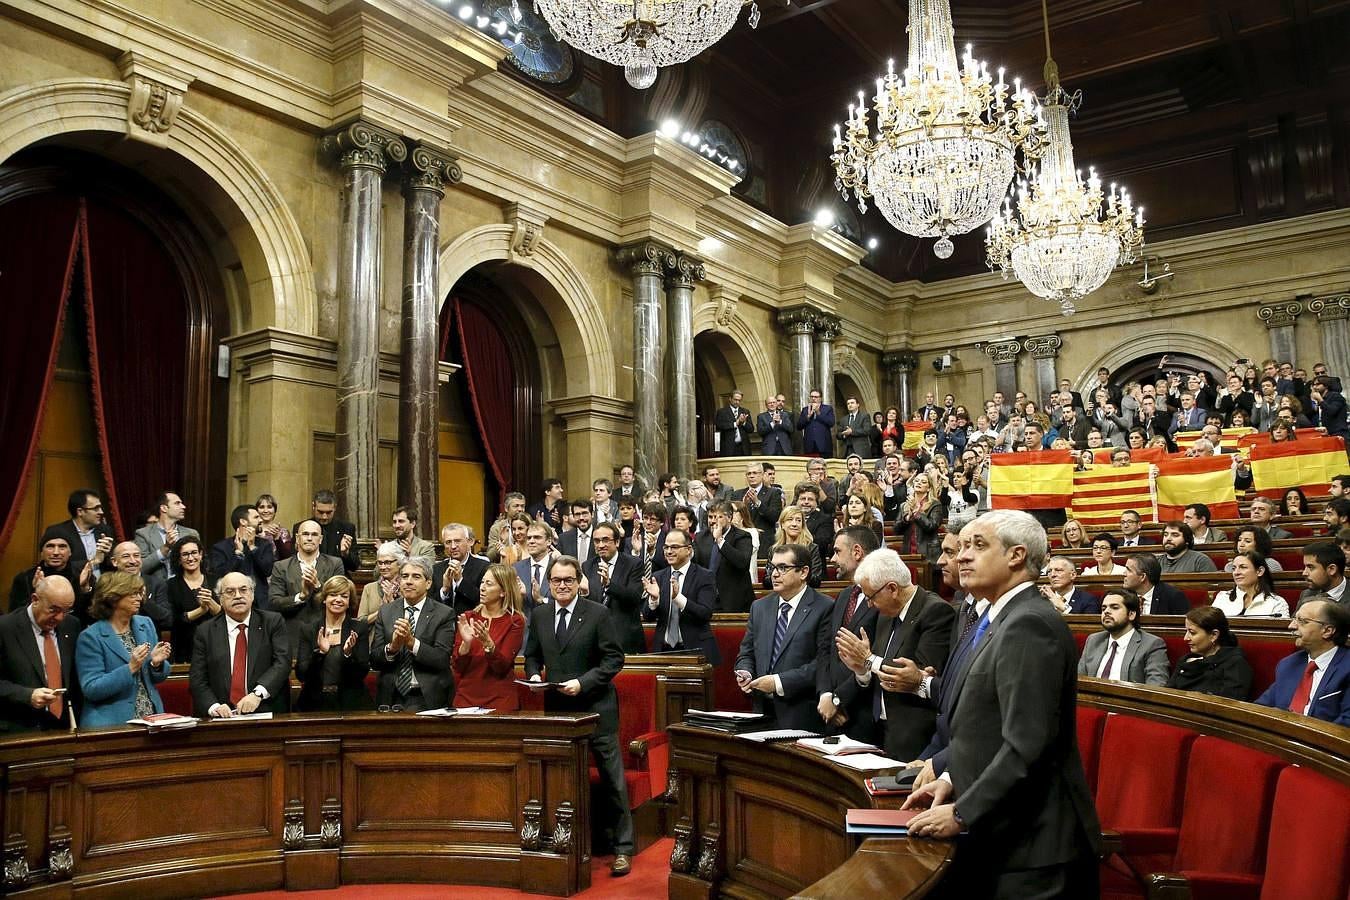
<box><xmin>736</xmin><ymin>587</ymin><xmax>833</xmax><ymax>731</ymax></box>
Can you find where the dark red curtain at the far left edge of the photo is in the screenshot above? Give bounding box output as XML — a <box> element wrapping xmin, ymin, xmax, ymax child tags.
<box><xmin>0</xmin><ymin>194</ymin><xmax>80</xmax><ymax>552</ymax></box>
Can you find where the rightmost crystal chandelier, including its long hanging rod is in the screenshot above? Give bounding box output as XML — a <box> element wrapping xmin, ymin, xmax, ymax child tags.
<box><xmin>986</xmin><ymin>0</ymin><xmax>1143</xmax><ymax>316</ymax></box>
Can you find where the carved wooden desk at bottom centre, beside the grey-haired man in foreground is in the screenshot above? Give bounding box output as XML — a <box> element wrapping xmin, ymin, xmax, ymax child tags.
<box><xmin>668</xmin><ymin>725</ymin><xmax>952</xmax><ymax>900</ymax></box>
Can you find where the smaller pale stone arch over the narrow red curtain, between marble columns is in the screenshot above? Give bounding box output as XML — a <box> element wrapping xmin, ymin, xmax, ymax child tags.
<box><xmin>439</xmin><ymin>225</ymin><xmax>617</xmax><ymax>397</ymax></box>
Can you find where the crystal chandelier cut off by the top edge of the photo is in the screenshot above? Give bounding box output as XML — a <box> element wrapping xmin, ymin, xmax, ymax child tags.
<box><xmin>531</xmin><ymin>0</ymin><xmax>777</xmax><ymax>90</ymax></box>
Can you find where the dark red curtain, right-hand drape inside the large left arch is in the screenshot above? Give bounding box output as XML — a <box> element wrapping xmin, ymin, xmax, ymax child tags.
<box><xmin>84</xmin><ymin>198</ymin><xmax>187</xmax><ymax>533</ymax></box>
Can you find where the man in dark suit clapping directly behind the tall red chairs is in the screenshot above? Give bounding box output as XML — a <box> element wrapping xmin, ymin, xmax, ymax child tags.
<box><xmin>643</xmin><ymin>529</ymin><xmax>722</xmax><ymax>665</ymax></box>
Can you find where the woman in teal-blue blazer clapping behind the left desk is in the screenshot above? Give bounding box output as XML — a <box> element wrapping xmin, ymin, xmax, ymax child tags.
<box><xmin>76</xmin><ymin>572</ymin><xmax>173</xmax><ymax>729</ymax></box>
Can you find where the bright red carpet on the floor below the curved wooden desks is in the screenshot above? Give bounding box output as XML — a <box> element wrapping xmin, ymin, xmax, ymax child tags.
<box><xmin>216</xmin><ymin>838</ymin><xmax>675</xmax><ymax>900</ymax></box>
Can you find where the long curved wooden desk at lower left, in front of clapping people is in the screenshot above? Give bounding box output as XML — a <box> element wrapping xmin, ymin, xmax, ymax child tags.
<box><xmin>0</xmin><ymin>712</ymin><xmax>597</xmax><ymax>900</ymax></box>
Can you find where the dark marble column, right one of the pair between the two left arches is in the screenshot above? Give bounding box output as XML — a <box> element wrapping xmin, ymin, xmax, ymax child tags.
<box><xmin>396</xmin><ymin>147</ymin><xmax>463</xmax><ymax>531</ymax></box>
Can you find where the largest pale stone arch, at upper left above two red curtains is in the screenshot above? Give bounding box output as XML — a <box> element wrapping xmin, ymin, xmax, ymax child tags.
<box><xmin>0</xmin><ymin>78</ymin><xmax>319</xmax><ymax>335</ymax></box>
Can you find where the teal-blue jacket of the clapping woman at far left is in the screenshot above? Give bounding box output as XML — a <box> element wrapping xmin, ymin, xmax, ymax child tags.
<box><xmin>76</xmin><ymin>615</ymin><xmax>171</xmax><ymax>729</ymax></box>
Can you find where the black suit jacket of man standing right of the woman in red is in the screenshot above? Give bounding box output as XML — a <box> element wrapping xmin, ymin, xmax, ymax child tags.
<box><xmin>525</xmin><ymin>596</ymin><xmax>624</xmax><ymax>734</ymax></box>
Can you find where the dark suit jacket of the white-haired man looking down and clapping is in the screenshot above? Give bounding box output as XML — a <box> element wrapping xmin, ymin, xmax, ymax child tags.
<box><xmin>868</xmin><ymin>588</ymin><xmax>956</xmax><ymax>760</ymax></box>
